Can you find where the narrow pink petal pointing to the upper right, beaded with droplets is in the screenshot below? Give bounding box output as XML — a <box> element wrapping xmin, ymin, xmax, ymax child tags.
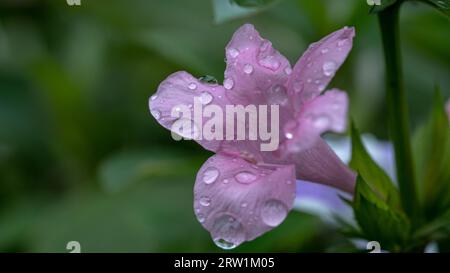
<box><xmin>288</xmin><ymin>27</ymin><xmax>355</xmax><ymax>111</ymax></box>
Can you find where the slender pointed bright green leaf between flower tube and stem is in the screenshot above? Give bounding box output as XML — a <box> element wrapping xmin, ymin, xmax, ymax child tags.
<box><xmin>350</xmin><ymin>123</ymin><xmax>400</xmax><ymax>209</ymax></box>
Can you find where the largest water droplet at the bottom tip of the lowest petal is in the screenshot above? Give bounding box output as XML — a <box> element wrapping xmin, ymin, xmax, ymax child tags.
<box><xmin>211</xmin><ymin>214</ymin><xmax>245</xmax><ymax>249</ymax></box>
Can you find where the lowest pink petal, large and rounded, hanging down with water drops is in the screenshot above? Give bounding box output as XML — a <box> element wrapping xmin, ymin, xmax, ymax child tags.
<box><xmin>194</xmin><ymin>154</ymin><xmax>296</xmax><ymax>248</ymax></box>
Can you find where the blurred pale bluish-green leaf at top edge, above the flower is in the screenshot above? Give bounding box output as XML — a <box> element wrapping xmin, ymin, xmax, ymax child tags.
<box><xmin>212</xmin><ymin>0</ymin><xmax>280</xmax><ymax>24</ymax></box>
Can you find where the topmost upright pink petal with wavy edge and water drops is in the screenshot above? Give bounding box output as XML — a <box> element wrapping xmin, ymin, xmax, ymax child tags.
<box><xmin>224</xmin><ymin>24</ymin><xmax>292</xmax><ymax>120</ymax></box>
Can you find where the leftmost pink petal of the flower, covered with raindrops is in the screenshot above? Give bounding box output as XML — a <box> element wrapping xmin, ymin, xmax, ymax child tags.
<box><xmin>149</xmin><ymin>71</ymin><xmax>230</xmax><ymax>151</ymax></box>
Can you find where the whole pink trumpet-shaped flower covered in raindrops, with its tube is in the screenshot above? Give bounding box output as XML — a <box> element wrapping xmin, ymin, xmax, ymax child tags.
<box><xmin>149</xmin><ymin>24</ymin><xmax>355</xmax><ymax>248</ymax></box>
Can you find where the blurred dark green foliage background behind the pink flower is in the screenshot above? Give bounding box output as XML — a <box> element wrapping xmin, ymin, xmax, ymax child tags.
<box><xmin>0</xmin><ymin>0</ymin><xmax>450</xmax><ymax>252</ymax></box>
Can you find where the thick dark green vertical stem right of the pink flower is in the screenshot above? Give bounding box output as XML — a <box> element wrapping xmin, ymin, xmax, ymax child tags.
<box><xmin>378</xmin><ymin>1</ymin><xmax>418</xmax><ymax>222</ymax></box>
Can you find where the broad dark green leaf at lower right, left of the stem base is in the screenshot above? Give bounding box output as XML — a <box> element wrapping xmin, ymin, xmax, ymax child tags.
<box><xmin>353</xmin><ymin>175</ymin><xmax>410</xmax><ymax>251</ymax></box>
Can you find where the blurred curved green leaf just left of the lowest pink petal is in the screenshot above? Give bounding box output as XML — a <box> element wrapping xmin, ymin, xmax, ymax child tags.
<box><xmin>99</xmin><ymin>149</ymin><xmax>197</xmax><ymax>192</ymax></box>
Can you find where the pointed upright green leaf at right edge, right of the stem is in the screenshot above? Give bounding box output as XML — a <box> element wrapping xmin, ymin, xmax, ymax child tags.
<box><xmin>413</xmin><ymin>88</ymin><xmax>450</xmax><ymax>218</ymax></box>
